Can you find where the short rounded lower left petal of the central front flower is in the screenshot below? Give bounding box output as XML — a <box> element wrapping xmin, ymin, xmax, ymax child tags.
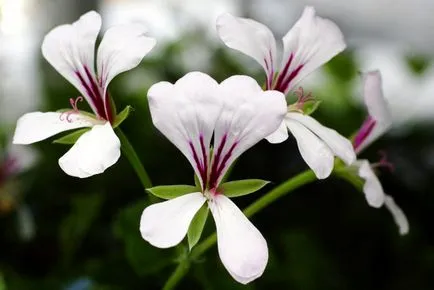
<box><xmin>140</xmin><ymin>192</ymin><xmax>206</xmax><ymax>248</ymax></box>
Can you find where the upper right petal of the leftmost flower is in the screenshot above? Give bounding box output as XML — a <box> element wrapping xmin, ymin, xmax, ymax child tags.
<box><xmin>97</xmin><ymin>24</ymin><xmax>156</xmax><ymax>88</ymax></box>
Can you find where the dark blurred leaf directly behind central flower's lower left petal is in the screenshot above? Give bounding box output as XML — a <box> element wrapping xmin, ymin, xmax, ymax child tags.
<box><xmin>113</xmin><ymin>200</ymin><xmax>176</xmax><ymax>276</ymax></box>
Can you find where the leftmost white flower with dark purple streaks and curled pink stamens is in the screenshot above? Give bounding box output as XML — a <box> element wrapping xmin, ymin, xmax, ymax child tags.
<box><xmin>13</xmin><ymin>11</ymin><xmax>155</xmax><ymax>178</ymax></box>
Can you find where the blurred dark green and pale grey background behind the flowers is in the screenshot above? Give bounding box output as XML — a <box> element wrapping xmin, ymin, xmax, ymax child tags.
<box><xmin>0</xmin><ymin>0</ymin><xmax>434</xmax><ymax>290</ymax></box>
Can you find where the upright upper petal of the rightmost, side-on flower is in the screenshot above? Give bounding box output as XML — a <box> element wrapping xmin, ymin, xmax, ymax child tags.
<box><xmin>357</xmin><ymin>71</ymin><xmax>392</xmax><ymax>153</ymax></box>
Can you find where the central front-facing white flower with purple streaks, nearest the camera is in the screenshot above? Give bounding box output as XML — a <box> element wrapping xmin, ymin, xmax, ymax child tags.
<box><xmin>140</xmin><ymin>72</ymin><xmax>286</xmax><ymax>284</ymax></box>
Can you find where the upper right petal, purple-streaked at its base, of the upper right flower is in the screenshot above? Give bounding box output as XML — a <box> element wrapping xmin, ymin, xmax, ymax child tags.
<box><xmin>280</xmin><ymin>7</ymin><xmax>346</xmax><ymax>92</ymax></box>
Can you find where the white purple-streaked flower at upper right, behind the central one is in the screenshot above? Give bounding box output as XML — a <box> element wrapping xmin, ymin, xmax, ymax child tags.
<box><xmin>217</xmin><ymin>7</ymin><xmax>355</xmax><ymax>179</ymax></box>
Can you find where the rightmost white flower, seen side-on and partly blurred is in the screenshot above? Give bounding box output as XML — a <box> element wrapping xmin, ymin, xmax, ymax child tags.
<box><xmin>351</xmin><ymin>71</ymin><xmax>409</xmax><ymax>235</ymax></box>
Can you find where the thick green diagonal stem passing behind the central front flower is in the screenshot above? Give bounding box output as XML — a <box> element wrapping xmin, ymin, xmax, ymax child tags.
<box><xmin>163</xmin><ymin>170</ymin><xmax>316</xmax><ymax>290</ymax></box>
